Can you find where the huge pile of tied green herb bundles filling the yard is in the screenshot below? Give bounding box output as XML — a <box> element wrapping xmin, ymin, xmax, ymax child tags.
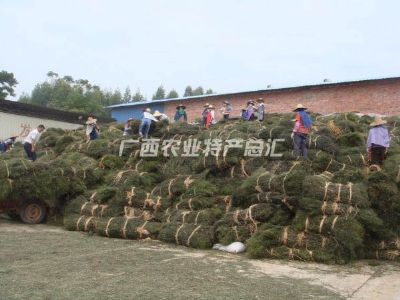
<box><xmin>0</xmin><ymin>113</ymin><xmax>400</xmax><ymax>263</ymax></box>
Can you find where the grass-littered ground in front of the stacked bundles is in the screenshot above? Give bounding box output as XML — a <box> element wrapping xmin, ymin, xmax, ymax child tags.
<box><xmin>0</xmin><ymin>219</ymin><xmax>400</xmax><ymax>300</ymax></box>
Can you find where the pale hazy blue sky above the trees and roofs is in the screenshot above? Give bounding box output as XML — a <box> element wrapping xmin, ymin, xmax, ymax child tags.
<box><xmin>0</xmin><ymin>0</ymin><xmax>400</xmax><ymax>99</ymax></box>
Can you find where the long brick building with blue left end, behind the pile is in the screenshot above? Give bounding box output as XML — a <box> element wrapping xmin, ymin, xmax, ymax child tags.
<box><xmin>109</xmin><ymin>77</ymin><xmax>400</xmax><ymax>122</ymax></box>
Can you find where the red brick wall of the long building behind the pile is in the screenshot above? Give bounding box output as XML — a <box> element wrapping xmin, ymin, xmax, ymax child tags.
<box><xmin>165</xmin><ymin>79</ymin><xmax>400</xmax><ymax>121</ymax></box>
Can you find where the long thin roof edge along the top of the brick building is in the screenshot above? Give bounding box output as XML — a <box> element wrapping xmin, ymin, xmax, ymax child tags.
<box><xmin>107</xmin><ymin>77</ymin><xmax>400</xmax><ymax>108</ymax></box>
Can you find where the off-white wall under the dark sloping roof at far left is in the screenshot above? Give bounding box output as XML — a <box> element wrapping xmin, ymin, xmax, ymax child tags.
<box><xmin>0</xmin><ymin>112</ymin><xmax>82</xmax><ymax>141</ymax></box>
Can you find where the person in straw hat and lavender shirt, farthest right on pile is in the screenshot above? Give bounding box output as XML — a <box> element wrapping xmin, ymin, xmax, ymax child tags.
<box><xmin>367</xmin><ymin>117</ymin><xmax>390</xmax><ymax>165</ymax></box>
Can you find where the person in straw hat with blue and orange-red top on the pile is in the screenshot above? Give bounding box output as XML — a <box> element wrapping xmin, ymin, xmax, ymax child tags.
<box><xmin>291</xmin><ymin>104</ymin><xmax>312</xmax><ymax>159</ymax></box>
